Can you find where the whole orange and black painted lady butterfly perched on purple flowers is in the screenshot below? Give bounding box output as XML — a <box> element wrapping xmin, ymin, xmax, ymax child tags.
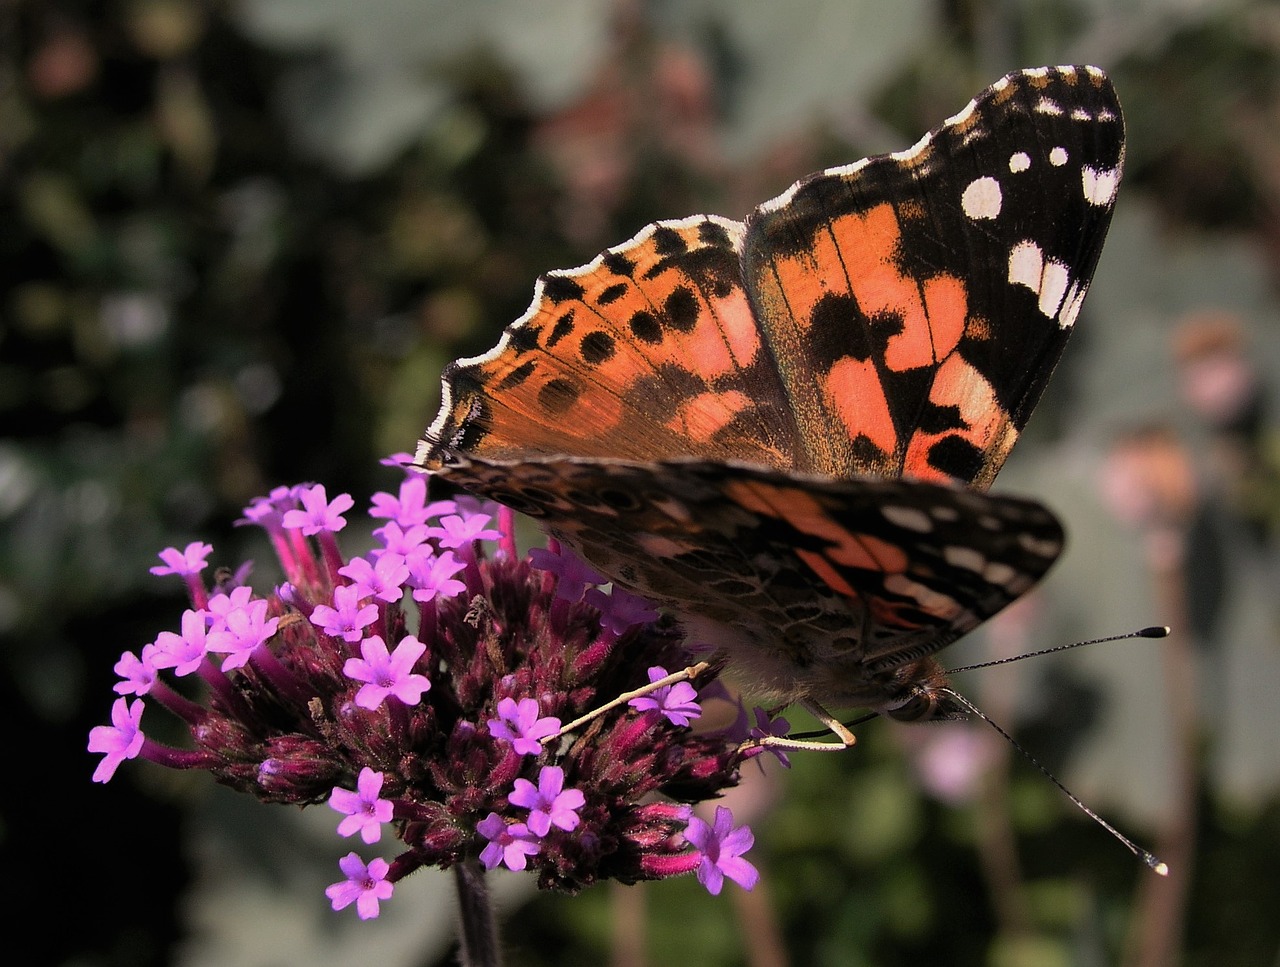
<box><xmin>417</xmin><ymin>67</ymin><xmax>1124</xmax><ymax>720</ymax></box>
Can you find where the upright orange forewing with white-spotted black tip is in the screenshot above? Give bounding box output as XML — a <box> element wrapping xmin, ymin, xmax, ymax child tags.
<box><xmin>744</xmin><ymin>68</ymin><xmax>1124</xmax><ymax>487</ymax></box>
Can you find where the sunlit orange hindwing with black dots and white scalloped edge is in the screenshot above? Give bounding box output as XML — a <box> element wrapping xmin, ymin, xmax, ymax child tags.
<box><xmin>426</xmin><ymin>218</ymin><xmax>796</xmax><ymax>476</ymax></box>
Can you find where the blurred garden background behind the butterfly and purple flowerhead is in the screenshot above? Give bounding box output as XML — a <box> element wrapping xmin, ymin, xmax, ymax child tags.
<box><xmin>0</xmin><ymin>0</ymin><xmax>1280</xmax><ymax>967</ymax></box>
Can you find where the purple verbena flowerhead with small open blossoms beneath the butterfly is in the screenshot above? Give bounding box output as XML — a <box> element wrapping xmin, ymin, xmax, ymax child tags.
<box><xmin>90</xmin><ymin>474</ymin><xmax>759</xmax><ymax>918</ymax></box>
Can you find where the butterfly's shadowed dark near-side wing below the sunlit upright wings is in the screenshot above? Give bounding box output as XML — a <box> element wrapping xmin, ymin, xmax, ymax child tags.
<box><xmin>451</xmin><ymin>459</ymin><xmax>1064</xmax><ymax>701</ymax></box>
